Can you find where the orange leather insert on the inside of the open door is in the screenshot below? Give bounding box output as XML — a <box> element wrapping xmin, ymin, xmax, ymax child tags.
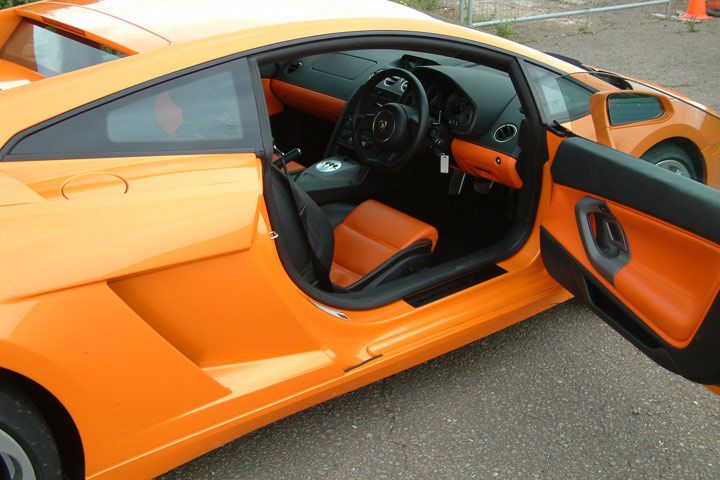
<box><xmin>543</xmin><ymin>185</ymin><xmax>720</xmax><ymax>348</ymax></box>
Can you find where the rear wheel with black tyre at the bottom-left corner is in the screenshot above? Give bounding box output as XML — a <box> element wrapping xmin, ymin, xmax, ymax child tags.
<box><xmin>0</xmin><ymin>380</ymin><xmax>62</xmax><ymax>480</ymax></box>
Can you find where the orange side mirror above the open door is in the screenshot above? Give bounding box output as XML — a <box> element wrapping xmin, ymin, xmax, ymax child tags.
<box><xmin>590</xmin><ymin>92</ymin><xmax>674</xmax><ymax>148</ymax></box>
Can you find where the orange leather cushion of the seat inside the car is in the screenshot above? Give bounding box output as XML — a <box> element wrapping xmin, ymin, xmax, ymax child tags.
<box><xmin>330</xmin><ymin>200</ymin><xmax>438</xmax><ymax>287</ymax></box>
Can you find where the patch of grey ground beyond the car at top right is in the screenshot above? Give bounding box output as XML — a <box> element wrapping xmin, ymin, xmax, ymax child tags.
<box><xmin>512</xmin><ymin>1</ymin><xmax>720</xmax><ymax>110</ymax></box>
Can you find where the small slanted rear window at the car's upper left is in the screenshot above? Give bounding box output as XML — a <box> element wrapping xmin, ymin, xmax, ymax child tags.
<box><xmin>0</xmin><ymin>20</ymin><xmax>124</xmax><ymax>77</ymax></box>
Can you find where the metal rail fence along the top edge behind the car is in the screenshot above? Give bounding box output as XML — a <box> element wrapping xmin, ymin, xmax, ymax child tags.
<box><xmin>420</xmin><ymin>0</ymin><xmax>673</xmax><ymax>27</ymax></box>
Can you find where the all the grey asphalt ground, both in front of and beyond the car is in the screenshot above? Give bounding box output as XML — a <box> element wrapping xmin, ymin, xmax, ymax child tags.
<box><xmin>163</xmin><ymin>5</ymin><xmax>720</xmax><ymax>480</ymax></box>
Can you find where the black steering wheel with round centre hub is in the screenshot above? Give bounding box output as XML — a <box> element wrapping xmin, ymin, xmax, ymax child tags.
<box><xmin>351</xmin><ymin>68</ymin><xmax>430</xmax><ymax>170</ymax></box>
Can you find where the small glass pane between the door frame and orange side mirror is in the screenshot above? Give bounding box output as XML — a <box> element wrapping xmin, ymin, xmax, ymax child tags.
<box><xmin>528</xmin><ymin>65</ymin><xmax>595</xmax><ymax>122</ymax></box>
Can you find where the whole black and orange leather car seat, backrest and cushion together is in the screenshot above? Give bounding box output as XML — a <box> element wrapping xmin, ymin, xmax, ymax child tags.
<box><xmin>270</xmin><ymin>168</ymin><xmax>438</xmax><ymax>291</ymax></box>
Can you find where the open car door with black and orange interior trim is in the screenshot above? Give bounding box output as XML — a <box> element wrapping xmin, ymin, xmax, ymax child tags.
<box><xmin>540</xmin><ymin>79</ymin><xmax>720</xmax><ymax>386</ymax></box>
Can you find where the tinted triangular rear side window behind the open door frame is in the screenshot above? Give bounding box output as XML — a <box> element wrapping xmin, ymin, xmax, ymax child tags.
<box><xmin>7</xmin><ymin>60</ymin><xmax>261</xmax><ymax>160</ymax></box>
